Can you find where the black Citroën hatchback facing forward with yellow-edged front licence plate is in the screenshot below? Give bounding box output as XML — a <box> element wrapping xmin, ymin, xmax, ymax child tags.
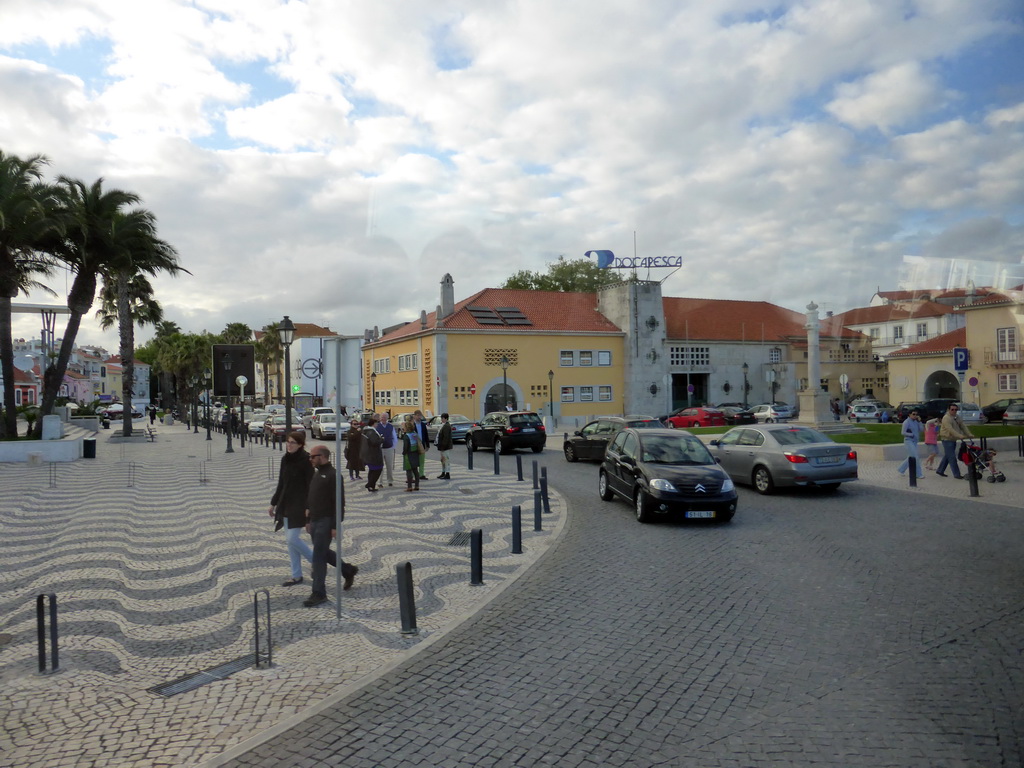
<box><xmin>598</xmin><ymin>429</ymin><xmax>736</xmax><ymax>522</ymax></box>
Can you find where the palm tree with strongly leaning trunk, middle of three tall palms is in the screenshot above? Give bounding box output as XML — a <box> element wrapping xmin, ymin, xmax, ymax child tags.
<box><xmin>40</xmin><ymin>176</ymin><xmax>139</xmax><ymax>436</ymax></box>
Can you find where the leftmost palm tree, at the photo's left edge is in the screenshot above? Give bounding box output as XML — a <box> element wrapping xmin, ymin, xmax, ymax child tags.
<box><xmin>0</xmin><ymin>152</ymin><xmax>62</xmax><ymax>437</ymax></box>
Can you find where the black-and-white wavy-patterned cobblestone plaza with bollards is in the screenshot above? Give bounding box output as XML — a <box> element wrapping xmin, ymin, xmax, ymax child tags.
<box><xmin>0</xmin><ymin>426</ymin><xmax>565</xmax><ymax>768</ymax></box>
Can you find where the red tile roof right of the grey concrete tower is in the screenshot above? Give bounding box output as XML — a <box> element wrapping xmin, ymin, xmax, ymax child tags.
<box><xmin>662</xmin><ymin>297</ymin><xmax>864</xmax><ymax>342</ymax></box>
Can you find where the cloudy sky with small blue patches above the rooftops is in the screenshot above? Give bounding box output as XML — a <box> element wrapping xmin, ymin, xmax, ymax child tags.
<box><xmin>0</xmin><ymin>0</ymin><xmax>1024</xmax><ymax>348</ymax></box>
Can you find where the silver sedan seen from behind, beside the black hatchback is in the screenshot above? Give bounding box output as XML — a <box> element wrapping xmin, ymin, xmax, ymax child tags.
<box><xmin>711</xmin><ymin>424</ymin><xmax>857</xmax><ymax>494</ymax></box>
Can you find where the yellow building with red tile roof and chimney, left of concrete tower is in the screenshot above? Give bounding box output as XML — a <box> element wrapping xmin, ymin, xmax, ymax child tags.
<box><xmin>362</xmin><ymin>274</ymin><xmax>625</xmax><ymax>424</ymax></box>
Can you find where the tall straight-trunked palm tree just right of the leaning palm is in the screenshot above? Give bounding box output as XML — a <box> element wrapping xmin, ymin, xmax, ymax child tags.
<box><xmin>102</xmin><ymin>209</ymin><xmax>187</xmax><ymax>436</ymax></box>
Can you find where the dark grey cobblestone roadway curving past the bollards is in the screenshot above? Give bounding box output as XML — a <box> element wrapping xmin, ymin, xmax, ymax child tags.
<box><xmin>220</xmin><ymin>448</ymin><xmax>1024</xmax><ymax>768</ymax></box>
